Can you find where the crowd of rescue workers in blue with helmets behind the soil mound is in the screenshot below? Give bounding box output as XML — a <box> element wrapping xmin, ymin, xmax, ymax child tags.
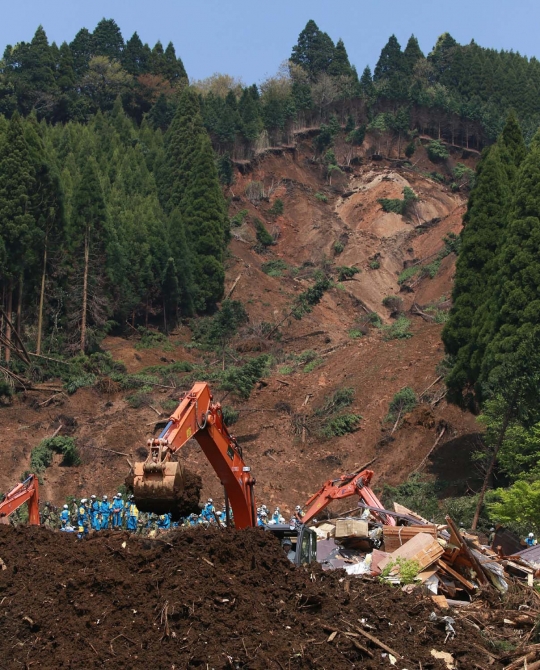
<box><xmin>41</xmin><ymin>493</ymin><xmax>302</xmax><ymax>539</ymax></box>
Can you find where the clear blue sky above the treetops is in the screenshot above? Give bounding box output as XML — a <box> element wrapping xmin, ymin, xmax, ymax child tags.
<box><xmin>0</xmin><ymin>0</ymin><xmax>540</xmax><ymax>84</ymax></box>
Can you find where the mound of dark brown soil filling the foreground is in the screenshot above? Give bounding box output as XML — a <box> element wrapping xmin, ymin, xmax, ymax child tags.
<box><xmin>0</xmin><ymin>526</ymin><xmax>520</xmax><ymax>670</ymax></box>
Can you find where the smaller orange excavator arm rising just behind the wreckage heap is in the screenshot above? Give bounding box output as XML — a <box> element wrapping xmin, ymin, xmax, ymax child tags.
<box><xmin>298</xmin><ymin>470</ymin><xmax>396</xmax><ymax>526</ymax></box>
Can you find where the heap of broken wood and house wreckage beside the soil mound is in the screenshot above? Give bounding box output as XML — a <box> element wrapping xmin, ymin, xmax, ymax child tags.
<box><xmin>314</xmin><ymin>503</ymin><xmax>540</xmax><ymax>607</ymax></box>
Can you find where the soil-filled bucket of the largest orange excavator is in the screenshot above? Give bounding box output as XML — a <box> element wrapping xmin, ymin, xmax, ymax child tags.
<box><xmin>126</xmin><ymin>461</ymin><xmax>202</xmax><ymax>521</ymax></box>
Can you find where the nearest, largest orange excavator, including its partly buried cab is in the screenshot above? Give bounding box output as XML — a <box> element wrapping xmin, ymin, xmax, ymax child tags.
<box><xmin>126</xmin><ymin>382</ymin><xmax>317</xmax><ymax>565</ymax></box>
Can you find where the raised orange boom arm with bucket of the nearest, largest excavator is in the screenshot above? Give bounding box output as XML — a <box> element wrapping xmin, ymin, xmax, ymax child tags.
<box><xmin>133</xmin><ymin>382</ymin><xmax>257</xmax><ymax>528</ymax></box>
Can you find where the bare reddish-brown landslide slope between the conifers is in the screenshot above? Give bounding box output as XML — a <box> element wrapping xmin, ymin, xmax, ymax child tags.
<box><xmin>0</xmin><ymin>147</ymin><xmax>477</xmax><ymax>510</ymax></box>
